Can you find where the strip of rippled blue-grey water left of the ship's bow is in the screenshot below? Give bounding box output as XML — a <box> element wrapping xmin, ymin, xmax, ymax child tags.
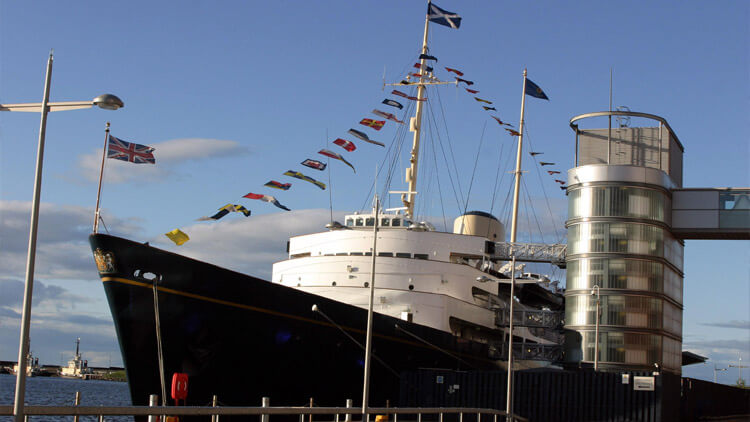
<box><xmin>0</xmin><ymin>374</ymin><xmax>133</xmax><ymax>422</ymax></box>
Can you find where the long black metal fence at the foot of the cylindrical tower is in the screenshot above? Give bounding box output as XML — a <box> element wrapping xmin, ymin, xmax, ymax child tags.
<box><xmin>406</xmin><ymin>369</ymin><xmax>750</xmax><ymax>422</ymax></box>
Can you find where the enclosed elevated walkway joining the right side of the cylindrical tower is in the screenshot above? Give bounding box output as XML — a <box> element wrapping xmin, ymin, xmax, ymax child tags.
<box><xmin>672</xmin><ymin>188</ymin><xmax>750</xmax><ymax>240</ymax></box>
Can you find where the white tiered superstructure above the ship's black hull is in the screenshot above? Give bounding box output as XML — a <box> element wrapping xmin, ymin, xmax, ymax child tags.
<box><xmin>272</xmin><ymin>213</ymin><xmax>548</xmax><ymax>343</ymax></box>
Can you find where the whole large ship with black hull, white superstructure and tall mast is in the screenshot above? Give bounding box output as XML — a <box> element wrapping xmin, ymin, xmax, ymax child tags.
<box><xmin>90</xmin><ymin>3</ymin><xmax>563</xmax><ymax>412</ymax></box>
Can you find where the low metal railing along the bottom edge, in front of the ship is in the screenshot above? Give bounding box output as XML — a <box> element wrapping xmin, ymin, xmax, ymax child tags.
<box><xmin>0</xmin><ymin>406</ymin><xmax>528</xmax><ymax>422</ymax></box>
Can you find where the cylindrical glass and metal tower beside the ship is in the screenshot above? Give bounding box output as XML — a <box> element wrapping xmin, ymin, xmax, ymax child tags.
<box><xmin>565</xmin><ymin>111</ymin><xmax>683</xmax><ymax>373</ymax></box>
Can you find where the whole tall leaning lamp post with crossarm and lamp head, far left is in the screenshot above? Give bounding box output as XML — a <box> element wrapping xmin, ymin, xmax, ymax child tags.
<box><xmin>0</xmin><ymin>51</ymin><xmax>124</xmax><ymax>422</ymax></box>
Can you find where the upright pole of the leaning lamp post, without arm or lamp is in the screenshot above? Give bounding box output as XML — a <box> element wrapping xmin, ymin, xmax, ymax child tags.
<box><xmin>13</xmin><ymin>51</ymin><xmax>52</xmax><ymax>422</ymax></box>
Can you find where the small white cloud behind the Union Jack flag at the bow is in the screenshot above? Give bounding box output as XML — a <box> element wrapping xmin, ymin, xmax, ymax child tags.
<box><xmin>78</xmin><ymin>138</ymin><xmax>247</xmax><ymax>183</ymax></box>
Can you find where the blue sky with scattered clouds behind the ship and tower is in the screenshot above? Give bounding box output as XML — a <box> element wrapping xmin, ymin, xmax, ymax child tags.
<box><xmin>0</xmin><ymin>0</ymin><xmax>750</xmax><ymax>383</ymax></box>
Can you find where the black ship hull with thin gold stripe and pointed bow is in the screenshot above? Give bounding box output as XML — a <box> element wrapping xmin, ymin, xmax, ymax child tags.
<box><xmin>90</xmin><ymin>234</ymin><xmax>497</xmax><ymax>406</ymax></box>
